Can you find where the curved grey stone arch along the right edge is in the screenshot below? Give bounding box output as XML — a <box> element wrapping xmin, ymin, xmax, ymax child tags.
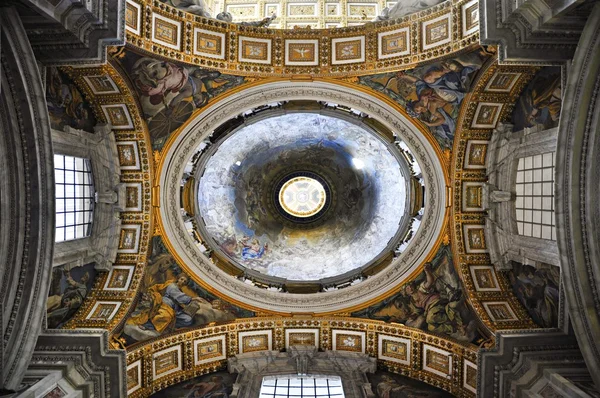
<box><xmin>555</xmin><ymin>4</ymin><xmax>600</xmax><ymax>388</ymax></box>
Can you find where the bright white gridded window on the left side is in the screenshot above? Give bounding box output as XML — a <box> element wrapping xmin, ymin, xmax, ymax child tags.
<box><xmin>54</xmin><ymin>155</ymin><xmax>94</xmax><ymax>242</ymax></box>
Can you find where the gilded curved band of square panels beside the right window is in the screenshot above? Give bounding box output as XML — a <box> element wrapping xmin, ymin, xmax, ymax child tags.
<box><xmin>452</xmin><ymin>59</ymin><xmax>538</xmax><ymax>332</ymax></box>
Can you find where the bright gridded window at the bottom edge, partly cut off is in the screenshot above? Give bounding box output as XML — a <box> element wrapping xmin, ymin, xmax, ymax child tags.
<box><xmin>259</xmin><ymin>375</ymin><xmax>344</xmax><ymax>398</ymax></box>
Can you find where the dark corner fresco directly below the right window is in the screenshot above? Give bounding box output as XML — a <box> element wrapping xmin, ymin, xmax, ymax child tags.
<box><xmin>507</xmin><ymin>262</ymin><xmax>560</xmax><ymax>328</ymax></box>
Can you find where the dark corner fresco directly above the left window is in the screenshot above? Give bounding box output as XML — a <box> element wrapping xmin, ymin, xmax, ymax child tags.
<box><xmin>46</xmin><ymin>66</ymin><xmax>96</xmax><ymax>133</ymax></box>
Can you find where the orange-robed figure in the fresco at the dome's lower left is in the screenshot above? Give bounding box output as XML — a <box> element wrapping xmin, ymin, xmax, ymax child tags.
<box><xmin>128</xmin><ymin>274</ymin><xmax>209</xmax><ymax>333</ymax></box>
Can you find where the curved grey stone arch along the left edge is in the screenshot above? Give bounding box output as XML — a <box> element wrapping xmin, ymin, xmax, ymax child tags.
<box><xmin>0</xmin><ymin>8</ymin><xmax>55</xmax><ymax>390</ymax></box>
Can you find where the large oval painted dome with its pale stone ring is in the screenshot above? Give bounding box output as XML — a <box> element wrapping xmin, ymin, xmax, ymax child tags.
<box><xmin>157</xmin><ymin>82</ymin><xmax>447</xmax><ymax>313</ymax></box>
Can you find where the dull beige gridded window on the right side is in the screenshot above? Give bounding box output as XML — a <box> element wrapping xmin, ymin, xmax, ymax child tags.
<box><xmin>515</xmin><ymin>152</ymin><xmax>556</xmax><ymax>240</ymax></box>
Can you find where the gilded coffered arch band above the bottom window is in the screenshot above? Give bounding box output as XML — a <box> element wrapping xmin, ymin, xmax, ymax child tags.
<box><xmin>127</xmin><ymin>316</ymin><xmax>477</xmax><ymax>398</ymax></box>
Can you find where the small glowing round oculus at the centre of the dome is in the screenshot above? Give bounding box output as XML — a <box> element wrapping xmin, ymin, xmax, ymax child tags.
<box><xmin>279</xmin><ymin>177</ymin><xmax>327</xmax><ymax>218</ymax></box>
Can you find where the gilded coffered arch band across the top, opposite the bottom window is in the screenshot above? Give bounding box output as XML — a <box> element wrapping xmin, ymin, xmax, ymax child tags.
<box><xmin>125</xmin><ymin>0</ymin><xmax>479</xmax><ymax>77</ymax></box>
